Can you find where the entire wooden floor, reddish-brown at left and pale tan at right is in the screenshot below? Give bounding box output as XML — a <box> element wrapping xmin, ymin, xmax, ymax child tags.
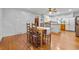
<box><xmin>0</xmin><ymin>31</ymin><xmax>79</xmax><ymax>50</ymax></box>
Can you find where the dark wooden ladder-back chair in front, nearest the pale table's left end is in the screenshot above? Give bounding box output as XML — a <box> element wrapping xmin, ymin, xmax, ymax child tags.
<box><xmin>32</xmin><ymin>24</ymin><xmax>40</xmax><ymax>47</ymax></box>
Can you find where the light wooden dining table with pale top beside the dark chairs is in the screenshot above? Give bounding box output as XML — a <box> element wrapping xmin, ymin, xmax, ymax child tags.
<box><xmin>37</xmin><ymin>27</ymin><xmax>50</xmax><ymax>47</ymax></box>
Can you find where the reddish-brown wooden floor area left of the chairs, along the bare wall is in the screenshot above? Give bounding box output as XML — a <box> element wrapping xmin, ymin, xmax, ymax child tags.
<box><xmin>0</xmin><ymin>34</ymin><xmax>28</xmax><ymax>50</ymax></box>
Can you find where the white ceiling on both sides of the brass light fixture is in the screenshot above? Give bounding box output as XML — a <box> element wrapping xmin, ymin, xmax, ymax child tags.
<box><xmin>21</xmin><ymin>8</ymin><xmax>79</xmax><ymax>15</ymax></box>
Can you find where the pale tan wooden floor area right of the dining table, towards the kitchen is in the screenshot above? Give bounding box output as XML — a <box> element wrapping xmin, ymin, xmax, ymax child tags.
<box><xmin>51</xmin><ymin>31</ymin><xmax>79</xmax><ymax>50</ymax></box>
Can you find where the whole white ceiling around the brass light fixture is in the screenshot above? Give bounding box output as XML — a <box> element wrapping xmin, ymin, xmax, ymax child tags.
<box><xmin>10</xmin><ymin>8</ymin><xmax>79</xmax><ymax>15</ymax></box>
